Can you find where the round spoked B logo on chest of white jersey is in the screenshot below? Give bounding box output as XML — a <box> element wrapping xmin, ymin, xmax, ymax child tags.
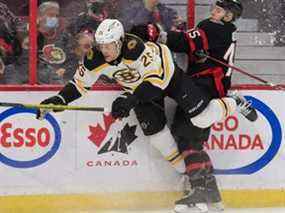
<box><xmin>113</xmin><ymin>69</ymin><xmax>141</xmax><ymax>84</ymax></box>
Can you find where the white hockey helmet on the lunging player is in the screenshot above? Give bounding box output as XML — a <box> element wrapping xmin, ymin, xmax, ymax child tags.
<box><xmin>95</xmin><ymin>19</ymin><xmax>125</xmax><ymax>44</ymax></box>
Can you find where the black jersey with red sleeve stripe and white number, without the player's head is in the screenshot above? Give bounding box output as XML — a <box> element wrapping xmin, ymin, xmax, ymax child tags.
<box><xmin>167</xmin><ymin>19</ymin><xmax>236</xmax><ymax>74</ymax></box>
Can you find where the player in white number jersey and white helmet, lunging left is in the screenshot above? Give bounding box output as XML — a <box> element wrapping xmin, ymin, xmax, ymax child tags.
<box><xmin>38</xmin><ymin>19</ymin><xmax>255</xmax><ymax>211</ymax></box>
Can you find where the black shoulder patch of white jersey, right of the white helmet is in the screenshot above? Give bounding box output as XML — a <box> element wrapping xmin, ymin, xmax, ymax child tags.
<box><xmin>122</xmin><ymin>33</ymin><xmax>145</xmax><ymax>61</ymax></box>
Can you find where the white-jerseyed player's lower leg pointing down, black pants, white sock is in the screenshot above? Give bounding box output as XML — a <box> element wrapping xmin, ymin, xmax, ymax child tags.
<box><xmin>135</xmin><ymin>99</ymin><xmax>185</xmax><ymax>173</ymax></box>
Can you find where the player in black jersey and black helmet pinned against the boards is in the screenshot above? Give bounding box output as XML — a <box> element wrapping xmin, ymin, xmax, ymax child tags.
<box><xmin>131</xmin><ymin>0</ymin><xmax>257</xmax><ymax>212</ymax></box>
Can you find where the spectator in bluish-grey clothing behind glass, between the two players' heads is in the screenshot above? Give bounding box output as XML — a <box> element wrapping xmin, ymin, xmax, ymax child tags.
<box><xmin>118</xmin><ymin>0</ymin><xmax>186</xmax><ymax>31</ymax></box>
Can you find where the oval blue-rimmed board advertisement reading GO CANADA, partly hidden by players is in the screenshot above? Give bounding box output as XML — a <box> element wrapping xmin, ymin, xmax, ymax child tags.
<box><xmin>205</xmin><ymin>96</ymin><xmax>282</xmax><ymax>175</ymax></box>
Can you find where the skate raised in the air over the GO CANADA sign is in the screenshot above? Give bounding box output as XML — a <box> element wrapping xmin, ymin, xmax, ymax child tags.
<box><xmin>229</xmin><ymin>91</ymin><xmax>257</xmax><ymax>122</ymax></box>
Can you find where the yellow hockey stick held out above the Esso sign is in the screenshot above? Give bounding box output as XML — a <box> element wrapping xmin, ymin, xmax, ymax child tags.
<box><xmin>0</xmin><ymin>102</ymin><xmax>109</xmax><ymax>112</ymax></box>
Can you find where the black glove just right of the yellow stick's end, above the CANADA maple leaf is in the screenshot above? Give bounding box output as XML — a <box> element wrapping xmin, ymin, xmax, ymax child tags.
<box><xmin>111</xmin><ymin>94</ymin><xmax>138</xmax><ymax>119</ymax></box>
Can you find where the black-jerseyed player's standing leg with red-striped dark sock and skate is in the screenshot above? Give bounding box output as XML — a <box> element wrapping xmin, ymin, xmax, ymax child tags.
<box><xmin>171</xmin><ymin>108</ymin><xmax>223</xmax><ymax>212</ymax></box>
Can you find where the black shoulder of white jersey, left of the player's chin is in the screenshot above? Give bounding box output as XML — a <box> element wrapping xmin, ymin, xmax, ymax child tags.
<box><xmin>83</xmin><ymin>47</ymin><xmax>106</xmax><ymax>71</ymax></box>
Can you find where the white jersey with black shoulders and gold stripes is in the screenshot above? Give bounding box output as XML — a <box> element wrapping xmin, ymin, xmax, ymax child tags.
<box><xmin>72</xmin><ymin>34</ymin><xmax>174</xmax><ymax>94</ymax></box>
